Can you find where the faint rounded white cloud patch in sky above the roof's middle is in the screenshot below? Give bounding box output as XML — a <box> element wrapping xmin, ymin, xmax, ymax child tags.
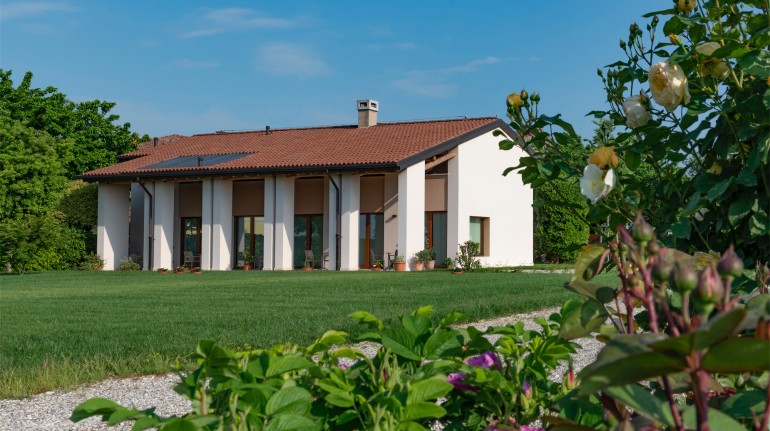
<box><xmin>255</xmin><ymin>42</ymin><xmax>332</xmax><ymax>79</ymax></box>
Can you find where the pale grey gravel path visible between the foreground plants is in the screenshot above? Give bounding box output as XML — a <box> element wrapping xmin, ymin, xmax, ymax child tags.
<box><xmin>0</xmin><ymin>308</ymin><xmax>602</xmax><ymax>431</ymax></box>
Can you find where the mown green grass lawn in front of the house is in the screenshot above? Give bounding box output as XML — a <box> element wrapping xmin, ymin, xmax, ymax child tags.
<box><xmin>0</xmin><ymin>271</ymin><xmax>592</xmax><ymax>398</ymax></box>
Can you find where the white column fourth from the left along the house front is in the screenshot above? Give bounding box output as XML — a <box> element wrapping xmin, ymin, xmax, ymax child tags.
<box><xmin>275</xmin><ymin>175</ymin><xmax>294</xmax><ymax>270</ymax></box>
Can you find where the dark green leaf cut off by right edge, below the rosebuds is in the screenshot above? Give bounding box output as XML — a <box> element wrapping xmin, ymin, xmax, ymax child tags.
<box><xmin>701</xmin><ymin>338</ymin><xmax>770</xmax><ymax>373</ymax></box>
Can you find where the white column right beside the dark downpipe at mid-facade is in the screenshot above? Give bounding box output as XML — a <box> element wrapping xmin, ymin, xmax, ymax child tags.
<box><xmin>340</xmin><ymin>174</ymin><xmax>361</xmax><ymax>271</ymax></box>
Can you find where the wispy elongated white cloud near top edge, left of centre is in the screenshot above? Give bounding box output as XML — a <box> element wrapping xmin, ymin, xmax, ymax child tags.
<box><xmin>179</xmin><ymin>8</ymin><xmax>296</xmax><ymax>39</ymax></box>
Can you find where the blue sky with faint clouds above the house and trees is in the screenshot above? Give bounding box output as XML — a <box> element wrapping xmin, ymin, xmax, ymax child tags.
<box><xmin>0</xmin><ymin>0</ymin><xmax>656</xmax><ymax>137</ymax></box>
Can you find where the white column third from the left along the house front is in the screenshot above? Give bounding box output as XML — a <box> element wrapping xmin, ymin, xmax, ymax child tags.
<box><xmin>211</xmin><ymin>178</ymin><xmax>233</xmax><ymax>271</ymax></box>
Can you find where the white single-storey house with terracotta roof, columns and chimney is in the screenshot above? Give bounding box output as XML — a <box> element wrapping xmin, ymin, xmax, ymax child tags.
<box><xmin>80</xmin><ymin>100</ymin><xmax>533</xmax><ymax>271</ymax></box>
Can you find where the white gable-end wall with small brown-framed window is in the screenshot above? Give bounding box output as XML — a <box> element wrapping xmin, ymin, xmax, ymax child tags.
<box><xmin>447</xmin><ymin>132</ymin><xmax>533</xmax><ymax>266</ymax></box>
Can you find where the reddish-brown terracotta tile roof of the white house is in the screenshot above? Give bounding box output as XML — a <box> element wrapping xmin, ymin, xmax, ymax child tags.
<box><xmin>80</xmin><ymin>117</ymin><xmax>512</xmax><ymax>180</ymax></box>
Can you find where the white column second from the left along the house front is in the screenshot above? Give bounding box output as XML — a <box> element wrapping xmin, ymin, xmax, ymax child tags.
<box><xmin>152</xmin><ymin>181</ymin><xmax>174</xmax><ymax>269</ymax></box>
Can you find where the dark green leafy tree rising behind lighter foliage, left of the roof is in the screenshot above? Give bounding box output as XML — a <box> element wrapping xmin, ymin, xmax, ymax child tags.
<box><xmin>0</xmin><ymin>69</ymin><xmax>143</xmax><ymax>178</ymax></box>
